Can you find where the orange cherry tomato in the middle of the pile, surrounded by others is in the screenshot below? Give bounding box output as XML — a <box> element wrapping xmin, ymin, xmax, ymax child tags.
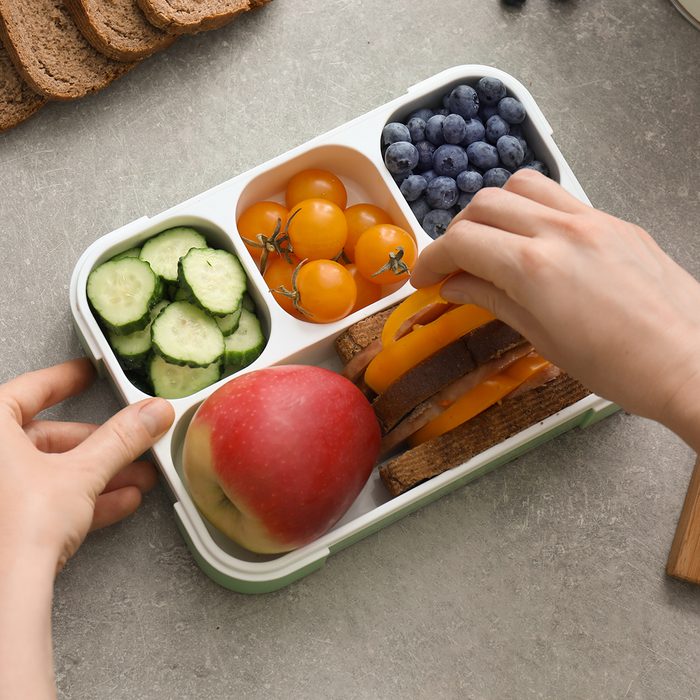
<box><xmin>287</xmin><ymin>199</ymin><xmax>348</xmax><ymax>260</ymax></box>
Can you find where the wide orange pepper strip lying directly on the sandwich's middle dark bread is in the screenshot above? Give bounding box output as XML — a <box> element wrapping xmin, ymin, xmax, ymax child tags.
<box><xmin>365</xmin><ymin>304</ymin><xmax>495</xmax><ymax>394</ymax></box>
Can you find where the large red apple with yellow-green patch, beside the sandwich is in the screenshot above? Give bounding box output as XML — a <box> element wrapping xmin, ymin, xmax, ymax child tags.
<box><xmin>183</xmin><ymin>365</ymin><xmax>380</xmax><ymax>554</ymax></box>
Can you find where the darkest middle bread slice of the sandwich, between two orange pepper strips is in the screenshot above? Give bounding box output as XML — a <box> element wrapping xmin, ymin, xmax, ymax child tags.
<box><xmin>372</xmin><ymin>321</ymin><xmax>527</xmax><ymax>433</ymax></box>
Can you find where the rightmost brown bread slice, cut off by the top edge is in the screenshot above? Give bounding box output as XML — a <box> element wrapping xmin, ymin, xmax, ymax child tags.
<box><xmin>137</xmin><ymin>0</ymin><xmax>269</xmax><ymax>34</ymax></box>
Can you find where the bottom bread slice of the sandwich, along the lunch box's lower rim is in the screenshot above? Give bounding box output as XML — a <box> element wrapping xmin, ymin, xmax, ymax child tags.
<box><xmin>379</xmin><ymin>374</ymin><xmax>590</xmax><ymax>496</ymax></box>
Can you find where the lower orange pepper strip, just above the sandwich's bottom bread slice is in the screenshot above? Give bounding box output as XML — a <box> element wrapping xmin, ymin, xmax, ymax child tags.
<box><xmin>408</xmin><ymin>353</ymin><xmax>549</xmax><ymax>447</ymax></box>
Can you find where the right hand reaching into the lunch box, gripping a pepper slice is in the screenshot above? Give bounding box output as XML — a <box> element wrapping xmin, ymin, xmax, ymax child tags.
<box><xmin>411</xmin><ymin>169</ymin><xmax>700</xmax><ymax>447</ymax></box>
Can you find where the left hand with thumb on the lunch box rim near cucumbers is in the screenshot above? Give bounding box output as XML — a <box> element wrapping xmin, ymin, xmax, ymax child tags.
<box><xmin>0</xmin><ymin>359</ymin><xmax>174</xmax><ymax>569</ymax></box>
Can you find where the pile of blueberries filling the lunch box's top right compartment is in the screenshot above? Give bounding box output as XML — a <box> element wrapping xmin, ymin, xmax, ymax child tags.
<box><xmin>382</xmin><ymin>78</ymin><xmax>549</xmax><ymax>238</ymax></box>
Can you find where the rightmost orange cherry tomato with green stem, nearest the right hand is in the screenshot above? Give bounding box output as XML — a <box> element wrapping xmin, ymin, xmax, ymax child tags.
<box><xmin>355</xmin><ymin>224</ymin><xmax>418</xmax><ymax>284</ymax></box>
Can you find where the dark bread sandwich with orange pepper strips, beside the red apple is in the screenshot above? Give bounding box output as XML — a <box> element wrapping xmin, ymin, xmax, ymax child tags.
<box><xmin>335</xmin><ymin>285</ymin><xmax>590</xmax><ymax>496</ymax></box>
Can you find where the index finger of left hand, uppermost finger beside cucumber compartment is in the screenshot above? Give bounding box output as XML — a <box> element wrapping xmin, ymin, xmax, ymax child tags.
<box><xmin>0</xmin><ymin>357</ymin><xmax>95</xmax><ymax>425</ymax></box>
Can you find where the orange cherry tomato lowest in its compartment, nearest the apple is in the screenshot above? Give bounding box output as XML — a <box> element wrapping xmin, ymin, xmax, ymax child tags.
<box><xmin>296</xmin><ymin>260</ymin><xmax>357</xmax><ymax>323</ymax></box>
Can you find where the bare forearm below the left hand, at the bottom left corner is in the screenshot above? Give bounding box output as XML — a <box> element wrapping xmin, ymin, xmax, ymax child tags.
<box><xmin>0</xmin><ymin>538</ymin><xmax>56</xmax><ymax>700</ymax></box>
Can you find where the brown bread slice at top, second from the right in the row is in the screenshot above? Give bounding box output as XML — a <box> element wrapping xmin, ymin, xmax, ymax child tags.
<box><xmin>64</xmin><ymin>0</ymin><xmax>177</xmax><ymax>61</ymax></box>
